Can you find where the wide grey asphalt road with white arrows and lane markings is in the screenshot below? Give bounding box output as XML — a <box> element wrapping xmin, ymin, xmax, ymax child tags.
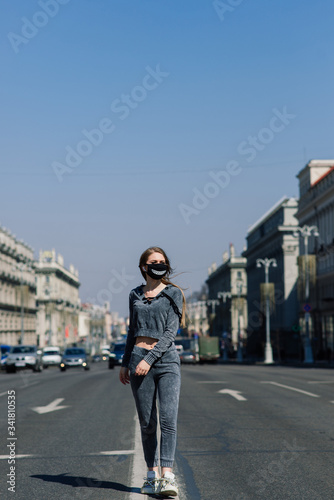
<box><xmin>0</xmin><ymin>363</ymin><xmax>334</xmax><ymax>500</ymax></box>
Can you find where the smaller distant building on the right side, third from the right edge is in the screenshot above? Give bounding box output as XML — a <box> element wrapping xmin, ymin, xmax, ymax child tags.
<box><xmin>206</xmin><ymin>243</ymin><xmax>248</xmax><ymax>351</ymax></box>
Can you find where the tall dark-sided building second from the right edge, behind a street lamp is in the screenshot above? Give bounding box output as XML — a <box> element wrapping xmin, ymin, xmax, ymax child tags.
<box><xmin>243</xmin><ymin>196</ymin><xmax>300</xmax><ymax>358</ymax></box>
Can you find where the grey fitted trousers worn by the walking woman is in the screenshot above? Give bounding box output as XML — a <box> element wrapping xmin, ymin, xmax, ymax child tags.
<box><xmin>129</xmin><ymin>344</ymin><xmax>181</xmax><ymax>467</ymax></box>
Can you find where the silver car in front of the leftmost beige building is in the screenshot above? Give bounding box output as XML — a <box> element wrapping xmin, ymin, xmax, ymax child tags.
<box><xmin>6</xmin><ymin>345</ymin><xmax>43</xmax><ymax>373</ymax></box>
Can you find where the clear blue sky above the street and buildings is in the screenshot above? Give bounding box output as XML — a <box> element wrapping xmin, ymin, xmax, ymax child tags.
<box><xmin>0</xmin><ymin>0</ymin><xmax>334</xmax><ymax>314</ymax></box>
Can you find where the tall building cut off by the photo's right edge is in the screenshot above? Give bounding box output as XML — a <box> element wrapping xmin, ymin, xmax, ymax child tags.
<box><xmin>296</xmin><ymin>159</ymin><xmax>334</xmax><ymax>360</ymax></box>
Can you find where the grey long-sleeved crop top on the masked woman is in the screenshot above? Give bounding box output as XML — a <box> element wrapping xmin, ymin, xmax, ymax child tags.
<box><xmin>122</xmin><ymin>285</ymin><xmax>183</xmax><ymax>367</ymax></box>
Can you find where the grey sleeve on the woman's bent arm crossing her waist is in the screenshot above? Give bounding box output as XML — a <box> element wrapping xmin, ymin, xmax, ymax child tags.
<box><xmin>144</xmin><ymin>287</ymin><xmax>183</xmax><ymax>365</ymax></box>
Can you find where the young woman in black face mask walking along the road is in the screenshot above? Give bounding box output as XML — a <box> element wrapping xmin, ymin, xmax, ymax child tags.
<box><xmin>119</xmin><ymin>247</ymin><xmax>185</xmax><ymax>496</ymax></box>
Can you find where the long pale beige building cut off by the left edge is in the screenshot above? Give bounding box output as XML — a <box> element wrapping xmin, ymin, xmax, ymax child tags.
<box><xmin>0</xmin><ymin>226</ymin><xmax>38</xmax><ymax>345</ymax></box>
